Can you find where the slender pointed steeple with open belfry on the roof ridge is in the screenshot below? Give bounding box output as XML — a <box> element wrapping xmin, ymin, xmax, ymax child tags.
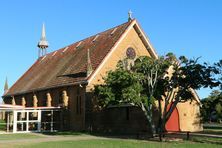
<box><xmin>37</xmin><ymin>23</ymin><xmax>49</xmax><ymax>57</ymax></box>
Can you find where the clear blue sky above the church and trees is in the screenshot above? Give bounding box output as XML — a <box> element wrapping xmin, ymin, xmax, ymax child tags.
<box><xmin>0</xmin><ymin>0</ymin><xmax>222</xmax><ymax>102</ymax></box>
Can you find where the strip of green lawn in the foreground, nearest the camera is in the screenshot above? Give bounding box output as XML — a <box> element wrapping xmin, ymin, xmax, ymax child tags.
<box><xmin>18</xmin><ymin>139</ymin><xmax>221</xmax><ymax>148</ymax></box>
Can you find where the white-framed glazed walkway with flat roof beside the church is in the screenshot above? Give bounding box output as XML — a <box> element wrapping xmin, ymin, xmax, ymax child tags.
<box><xmin>0</xmin><ymin>104</ymin><xmax>61</xmax><ymax>133</ymax></box>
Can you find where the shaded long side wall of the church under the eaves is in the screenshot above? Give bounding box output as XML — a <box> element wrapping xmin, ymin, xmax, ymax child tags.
<box><xmin>4</xmin><ymin>86</ymin><xmax>85</xmax><ymax>130</ymax></box>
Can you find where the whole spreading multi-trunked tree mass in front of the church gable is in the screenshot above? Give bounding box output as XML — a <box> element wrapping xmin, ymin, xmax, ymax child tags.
<box><xmin>95</xmin><ymin>53</ymin><xmax>220</xmax><ymax>140</ymax></box>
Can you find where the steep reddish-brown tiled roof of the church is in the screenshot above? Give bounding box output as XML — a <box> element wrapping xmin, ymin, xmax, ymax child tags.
<box><xmin>3</xmin><ymin>21</ymin><xmax>131</xmax><ymax>97</ymax></box>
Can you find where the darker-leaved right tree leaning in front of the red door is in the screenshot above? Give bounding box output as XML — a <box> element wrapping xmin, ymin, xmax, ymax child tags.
<box><xmin>153</xmin><ymin>54</ymin><xmax>220</xmax><ymax>139</ymax></box>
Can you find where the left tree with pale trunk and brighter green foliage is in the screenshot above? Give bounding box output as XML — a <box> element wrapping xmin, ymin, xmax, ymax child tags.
<box><xmin>95</xmin><ymin>56</ymin><xmax>171</xmax><ymax>137</ymax></box>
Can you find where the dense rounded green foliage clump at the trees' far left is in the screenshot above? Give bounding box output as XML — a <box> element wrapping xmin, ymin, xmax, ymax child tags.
<box><xmin>95</xmin><ymin>68</ymin><xmax>145</xmax><ymax>107</ymax></box>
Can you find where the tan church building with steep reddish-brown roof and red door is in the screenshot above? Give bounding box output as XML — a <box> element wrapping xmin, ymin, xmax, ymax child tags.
<box><xmin>3</xmin><ymin>15</ymin><xmax>202</xmax><ymax>132</ymax></box>
